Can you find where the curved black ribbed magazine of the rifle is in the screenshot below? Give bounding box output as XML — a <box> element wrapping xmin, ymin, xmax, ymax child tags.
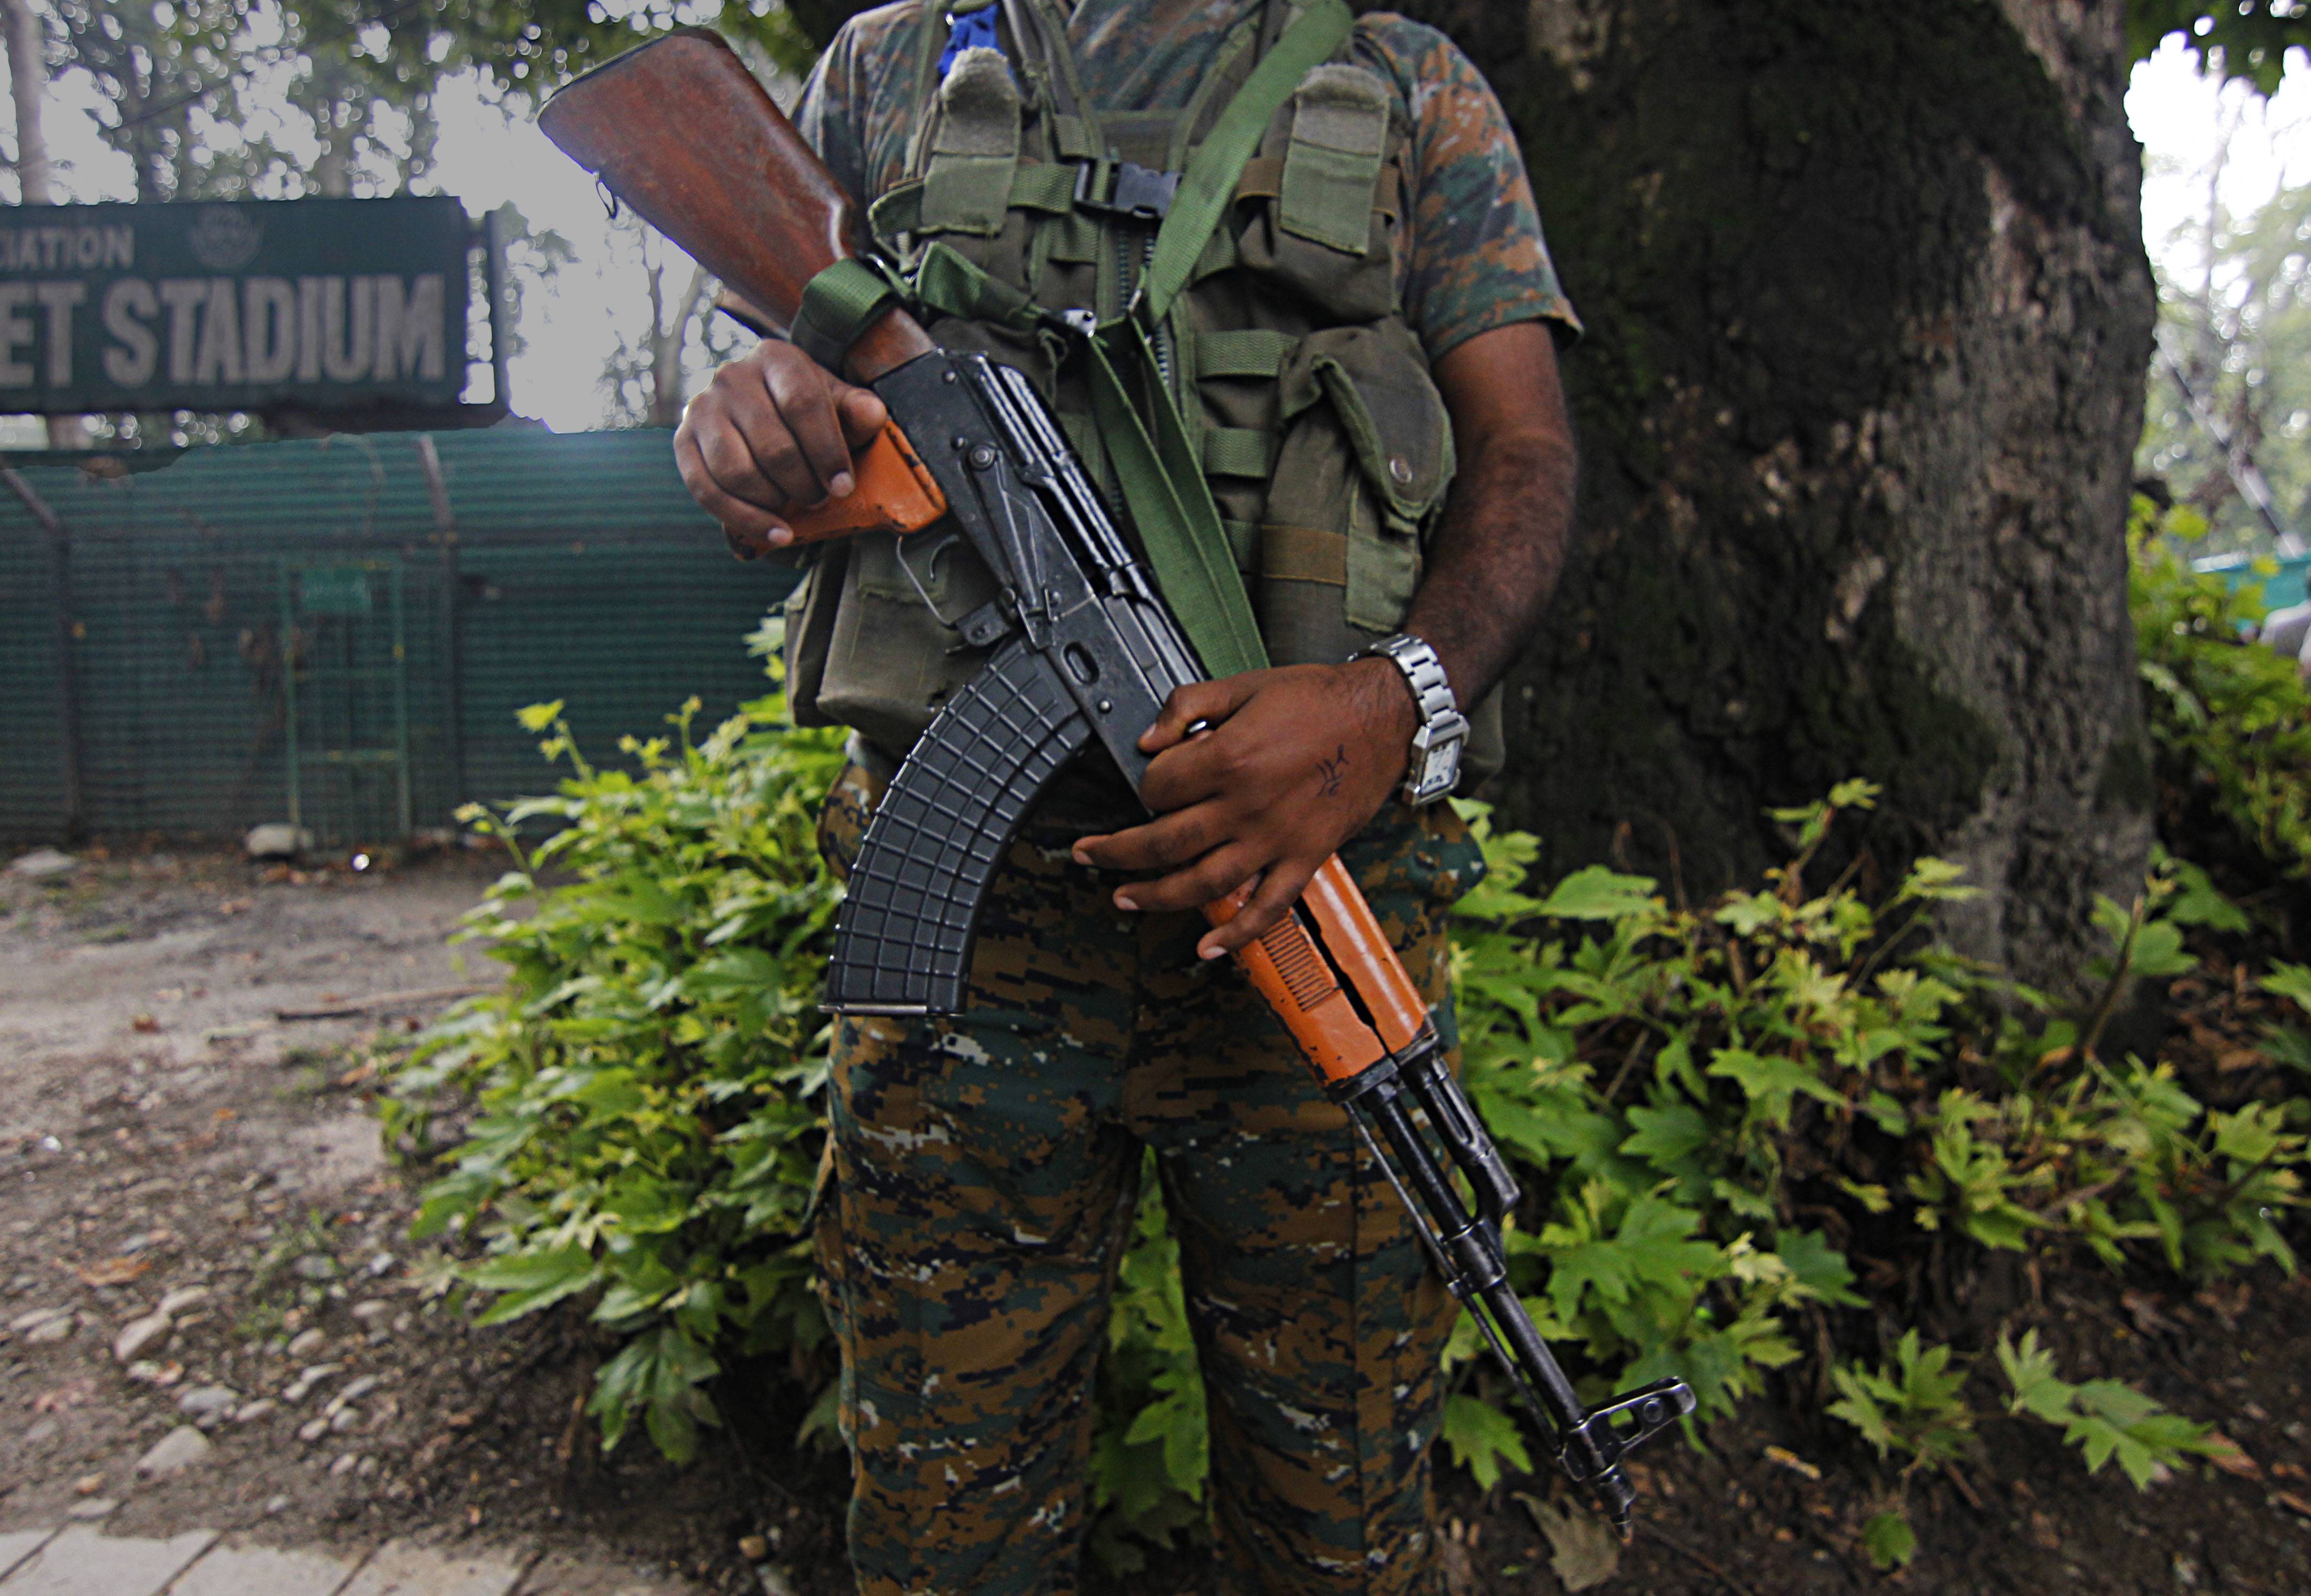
<box><xmin>825</xmin><ymin>637</ymin><xmax>1091</xmax><ymax>1014</ymax></box>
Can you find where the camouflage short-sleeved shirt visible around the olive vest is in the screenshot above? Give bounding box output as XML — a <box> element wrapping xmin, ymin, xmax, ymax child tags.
<box><xmin>795</xmin><ymin>0</ymin><xmax>1581</xmax><ymax>361</ymax></box>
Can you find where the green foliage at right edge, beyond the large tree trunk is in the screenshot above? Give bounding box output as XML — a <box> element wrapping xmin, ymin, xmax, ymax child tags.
<box><xmin>2126</xmin><ymin>499</ymin><xmax>2311</xmax><ymax>880</ymax></box>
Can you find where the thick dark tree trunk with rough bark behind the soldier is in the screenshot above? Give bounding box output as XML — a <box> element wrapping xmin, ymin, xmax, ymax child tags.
<box><xmin>1405</xmin><ymin>0</ymin><xmax>2154</xmax><ymax>986</ymax></box>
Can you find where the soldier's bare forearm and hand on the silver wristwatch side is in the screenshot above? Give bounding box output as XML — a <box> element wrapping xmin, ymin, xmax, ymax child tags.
<box><xmin>1075</xmin><ymin>321</ymin><xmax>1574</xmax><ymax>959</ymax></box>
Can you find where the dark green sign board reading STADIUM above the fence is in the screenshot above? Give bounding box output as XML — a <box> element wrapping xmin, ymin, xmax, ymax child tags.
<box><xmin>0</xmin><ymin>197</ymin><xmax>474</xmax><ymax>413</ymax></box>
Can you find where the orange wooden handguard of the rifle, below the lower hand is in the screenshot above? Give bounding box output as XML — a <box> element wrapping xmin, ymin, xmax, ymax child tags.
<box><xmin>1204</xmin><ymin>855</ymin><xmax>1428</xmax><ymax>1085</ymax></box>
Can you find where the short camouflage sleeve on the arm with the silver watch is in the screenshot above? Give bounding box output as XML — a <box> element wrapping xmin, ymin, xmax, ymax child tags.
<box><xmin>1359</xmin><ymin>12</ymin><xmax>1581</xmax><ymax>361</ymax></box>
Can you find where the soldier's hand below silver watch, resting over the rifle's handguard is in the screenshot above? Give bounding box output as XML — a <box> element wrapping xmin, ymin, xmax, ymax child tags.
<box><xmin>1075</xmin><ymin>658</ymin><xmax>1419</xmax><ymax>959</ymax></box>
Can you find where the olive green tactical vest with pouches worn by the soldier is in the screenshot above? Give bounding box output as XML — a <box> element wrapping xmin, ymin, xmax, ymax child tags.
<box><xmin>786</xmin><ymin>0</ymin><xmax>1502</xmax><ymax>785</ymax></box>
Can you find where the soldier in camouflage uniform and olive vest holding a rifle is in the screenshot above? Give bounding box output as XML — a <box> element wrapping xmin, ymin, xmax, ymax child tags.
<box><xmin>675</xmin><ymin>0</ymin><xmax>1576</xmax><ymax>1596</ymax></box>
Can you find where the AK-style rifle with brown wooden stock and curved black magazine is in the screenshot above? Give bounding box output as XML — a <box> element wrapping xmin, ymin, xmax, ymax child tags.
<box><xmin>538</xmin><ymin>30</ymin><xmax>1694</xmax><ymax>1534</ymax></box>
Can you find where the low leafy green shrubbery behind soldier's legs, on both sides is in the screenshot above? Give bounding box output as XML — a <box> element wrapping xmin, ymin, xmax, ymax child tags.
<box><xmin>391</xmin><ymin>700</ymin><xmax>2311</xmax><ymax>1566</ymax></box>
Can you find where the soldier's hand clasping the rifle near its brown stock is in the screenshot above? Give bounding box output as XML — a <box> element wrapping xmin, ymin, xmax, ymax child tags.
<box><xmin>675</xmin><ymin>337</ymin><xmax>890</xmax><ymax>559</ymax></box>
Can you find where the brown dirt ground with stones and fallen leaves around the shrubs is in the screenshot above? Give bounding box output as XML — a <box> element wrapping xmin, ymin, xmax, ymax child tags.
<box><xmin>0</xmin><ymin>850</ymin><xmax>2311</xmax><ymax>1596</ymax></box>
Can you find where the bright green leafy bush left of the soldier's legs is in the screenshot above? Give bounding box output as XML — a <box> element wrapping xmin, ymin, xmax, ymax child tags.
<box><xmin>388</xmin><ymin>700</ymin><xmax>841</xmax><ymax>1458</ymax></box>
